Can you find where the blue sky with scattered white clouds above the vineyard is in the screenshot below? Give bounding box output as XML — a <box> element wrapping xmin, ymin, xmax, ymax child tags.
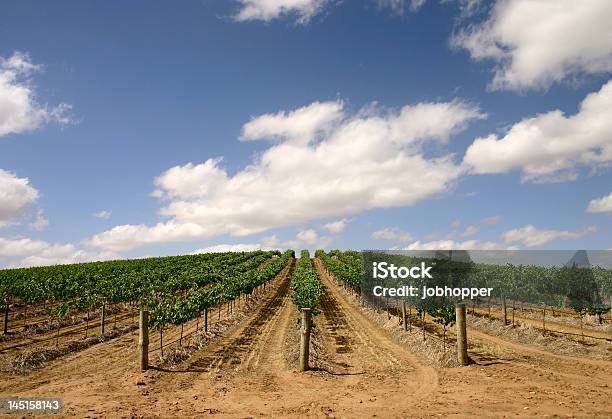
<box><xmin>0</xmin><ymin>0</ymin><xmax>612</xmax><ymax>266</ymax></box>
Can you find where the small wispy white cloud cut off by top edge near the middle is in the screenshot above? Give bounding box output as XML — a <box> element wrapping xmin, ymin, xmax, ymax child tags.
<box><xmin>234</xmin><ymin>0</ymin><xmax>328</xmax><ymax>24</ymax></box>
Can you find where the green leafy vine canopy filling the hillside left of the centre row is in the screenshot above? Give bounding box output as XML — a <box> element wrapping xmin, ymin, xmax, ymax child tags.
<box><xmin>0</xmin><ymin>251</ymin><xmax>292</xmax><ymax>327</ymax></box>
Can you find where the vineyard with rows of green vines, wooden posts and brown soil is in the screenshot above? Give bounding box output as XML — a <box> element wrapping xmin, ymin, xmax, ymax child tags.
<box><xmin>0</xmin><ymin>250</ymin><xmax>612</xmax><ymax>417</ymax></box>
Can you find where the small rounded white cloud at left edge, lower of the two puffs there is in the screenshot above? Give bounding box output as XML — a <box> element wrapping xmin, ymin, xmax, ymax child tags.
<box><xmin>0</xmin><ymin>169</ymin><xmax>38</xmax><ymax>227</ymax></box>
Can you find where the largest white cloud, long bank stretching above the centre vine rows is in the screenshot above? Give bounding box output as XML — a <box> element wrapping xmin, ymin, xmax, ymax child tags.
<box><xmin>90</xmin><ymin>101</ymin><xmax>484</xmax><ymax>251</ymax></box>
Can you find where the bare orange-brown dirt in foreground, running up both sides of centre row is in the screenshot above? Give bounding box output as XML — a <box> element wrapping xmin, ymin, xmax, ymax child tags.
<box><xmin>0</xmin><ymin>261</ymin><xmax>612</xmax><ymax>418</ymax></box>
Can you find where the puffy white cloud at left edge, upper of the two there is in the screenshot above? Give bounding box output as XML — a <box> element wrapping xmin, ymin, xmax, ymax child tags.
<box><xmin>0</xmin><ymin>52</ymin><xmax>70</xmax><ymax>137</ymax></box>
